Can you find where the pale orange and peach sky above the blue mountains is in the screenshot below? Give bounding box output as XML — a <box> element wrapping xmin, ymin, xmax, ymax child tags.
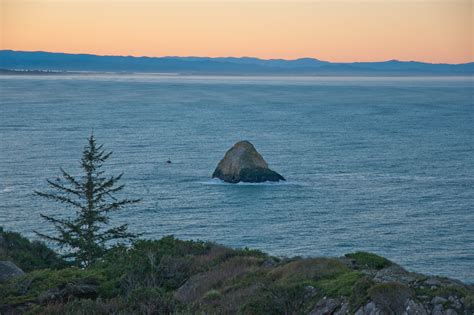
<box><xmin>0</xmin><ymin>0</ymin><xmax>474</xmax><ymax>63</ymax></box>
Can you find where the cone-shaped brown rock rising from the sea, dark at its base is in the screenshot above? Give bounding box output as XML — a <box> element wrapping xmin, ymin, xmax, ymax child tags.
<box><xmin>212</xmin><ymin>141</ymin><xmax>285</xmax><ymax>183</ymax></box>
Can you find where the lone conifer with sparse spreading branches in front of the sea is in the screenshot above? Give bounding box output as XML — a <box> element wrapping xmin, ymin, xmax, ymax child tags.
<box><xmin>35</xmin><ymin>135</ymin><xmax>140</xmax><ymax>266</ymax></box>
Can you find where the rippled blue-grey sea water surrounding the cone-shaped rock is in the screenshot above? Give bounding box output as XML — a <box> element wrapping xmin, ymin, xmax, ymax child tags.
<box><xmin>0</xmin><ymin>75</ymin><xmax>474</xmax><ymax>282</ymax></box>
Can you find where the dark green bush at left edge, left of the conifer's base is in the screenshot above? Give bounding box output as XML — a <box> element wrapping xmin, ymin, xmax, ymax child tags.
<box><xmin>0</xmin><ymin>227</ymin><xmax>67</xmax><ymax>272</ymax></box>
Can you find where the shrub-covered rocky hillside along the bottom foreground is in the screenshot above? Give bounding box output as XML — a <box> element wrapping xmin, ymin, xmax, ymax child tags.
<box><xmin>0</xmin><ymin>230</ymin><xmax>474</xmax><ymax>314</ymax></box>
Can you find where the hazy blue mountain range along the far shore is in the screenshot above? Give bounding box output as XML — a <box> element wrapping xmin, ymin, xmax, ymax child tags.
<box><xmin>0</xmin><ymin>50</ymin><xmax>474</xmax><ymax>75</ymax></box>
